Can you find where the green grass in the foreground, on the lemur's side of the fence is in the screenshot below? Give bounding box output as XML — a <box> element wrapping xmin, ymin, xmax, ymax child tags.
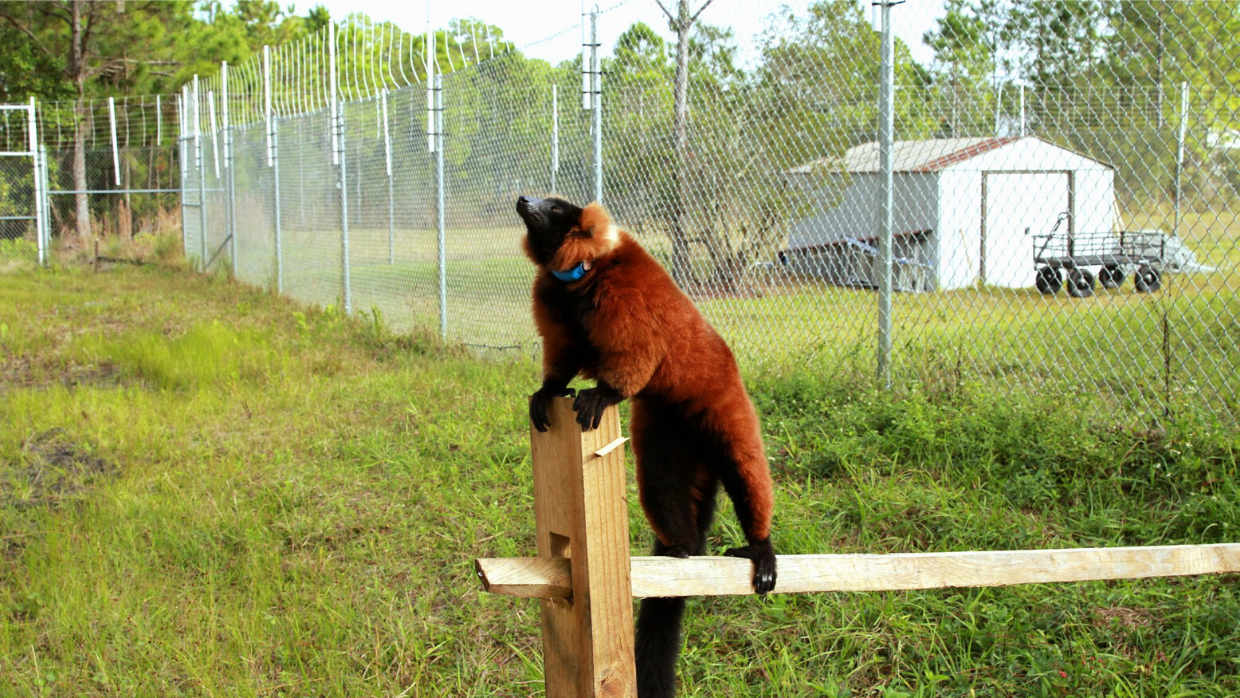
<box><xmin>0</xmin><ymin>268</ymin><xmax>1240</xmax><ymax>698</ymax></box>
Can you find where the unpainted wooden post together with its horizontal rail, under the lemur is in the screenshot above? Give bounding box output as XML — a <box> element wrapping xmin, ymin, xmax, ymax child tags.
<box><xmin>475</xmin><ymin>398</ymin><xmax>1240</xmax><ymax>698</ymax></box>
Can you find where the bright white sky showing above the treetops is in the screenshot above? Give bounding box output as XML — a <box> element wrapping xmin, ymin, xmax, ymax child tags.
<box><xmin>296</xmin><ymin>0</ymin><xmax>944</xmax><ymax>64</ymax></box>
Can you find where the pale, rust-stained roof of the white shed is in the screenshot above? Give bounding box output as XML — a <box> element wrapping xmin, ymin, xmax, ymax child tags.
<box><xmin>789</xmin><ymin>136</ymin><xmax>1111</xmax><ymax>175</ymax></box>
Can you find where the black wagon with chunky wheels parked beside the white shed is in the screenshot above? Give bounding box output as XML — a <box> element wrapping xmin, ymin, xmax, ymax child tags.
<box><xmin>1032</xmin><ymin>213</ymin><xmax>1175</xmax><ymax>298</ymax></box>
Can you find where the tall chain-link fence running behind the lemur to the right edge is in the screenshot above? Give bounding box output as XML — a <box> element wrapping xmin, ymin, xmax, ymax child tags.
<box><xmin>181</xmin><ymin>0</ymin><xmax>1240</xmax><ymax>420</ymax></box>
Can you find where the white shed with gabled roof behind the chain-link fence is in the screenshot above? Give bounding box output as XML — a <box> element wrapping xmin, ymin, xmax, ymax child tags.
<box><xmin>784</xmin><ymin>136</ymin><xmax>1116</xmax><ymax>291</ymax></box>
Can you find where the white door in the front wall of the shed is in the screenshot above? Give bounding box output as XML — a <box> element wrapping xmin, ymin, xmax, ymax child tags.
<box><xmin>981</xmin><ymin>172</ymin><xmax>1073</xmax><ymax>289</ymax></box>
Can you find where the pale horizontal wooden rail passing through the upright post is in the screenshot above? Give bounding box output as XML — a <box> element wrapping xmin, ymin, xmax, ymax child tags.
<box><xmin>476</xmin><ymin>543</ymin><xmax>1240</xmax><ymax>599</ymax></box>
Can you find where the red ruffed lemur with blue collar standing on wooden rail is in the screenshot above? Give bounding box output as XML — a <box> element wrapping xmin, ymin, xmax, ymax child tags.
<box><xmin>517</xmin><ymin>196</ymin><xmax>775</xmax><ymax>698</ymax></box>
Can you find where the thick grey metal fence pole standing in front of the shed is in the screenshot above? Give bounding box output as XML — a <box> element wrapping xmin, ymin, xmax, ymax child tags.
<box><xmin>878</xmin><ymin>0</ymin><xmax>894</xmax><ymax>388</ymax></box>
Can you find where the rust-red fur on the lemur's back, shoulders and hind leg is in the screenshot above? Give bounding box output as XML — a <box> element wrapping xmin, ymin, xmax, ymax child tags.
<box><xmin>523</xmin><ymin>202</ymin><xmax>774</xmax><ymax>546</ymax></box>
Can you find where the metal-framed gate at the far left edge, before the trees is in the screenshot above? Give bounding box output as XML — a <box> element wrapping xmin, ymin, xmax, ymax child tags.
<box><xmin>0</xmin><ymin>98</ymin><xmax>51</xmax><ymax>270</ymax></box>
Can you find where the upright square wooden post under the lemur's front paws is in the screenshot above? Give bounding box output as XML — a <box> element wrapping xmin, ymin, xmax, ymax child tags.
<box><xmin>529</xmin><ymin>398</ymin><xmax>637</xmax><ymax>698</ymax></box>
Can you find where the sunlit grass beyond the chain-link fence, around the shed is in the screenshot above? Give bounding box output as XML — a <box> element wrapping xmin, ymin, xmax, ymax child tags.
<box><xmin>205</xmin><ymin>211</ymin><xmax>1240</xmax><ymax>420</ymax></box>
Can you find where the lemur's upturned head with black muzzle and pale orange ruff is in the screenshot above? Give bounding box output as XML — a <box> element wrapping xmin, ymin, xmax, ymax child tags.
<box><xmin>517</xmin><ymin>196</ymin><xmax>620</xmax><ymax>281</ymax></box>
